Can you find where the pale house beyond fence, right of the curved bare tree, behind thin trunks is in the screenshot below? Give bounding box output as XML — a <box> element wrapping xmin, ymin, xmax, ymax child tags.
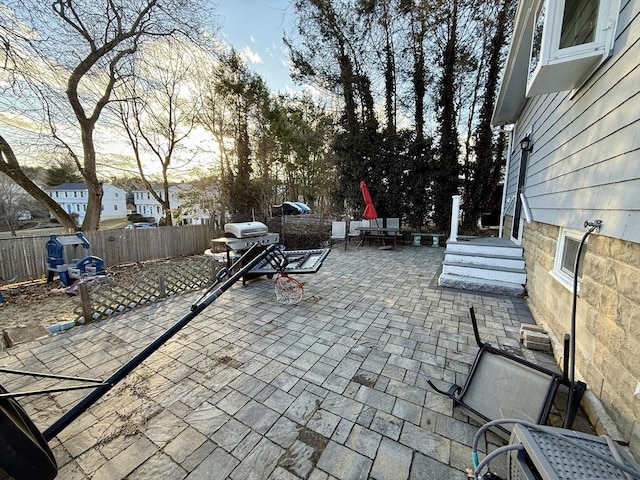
<box><xmin>132</xmin><ymin>184</ymin><xmax>207</xmax><ymax>225</ymax></box>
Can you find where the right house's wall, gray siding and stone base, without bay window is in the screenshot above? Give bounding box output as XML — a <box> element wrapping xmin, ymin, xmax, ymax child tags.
<box><xmin>494</xmin><ymin>0</ymin><xmax>640</xmax><ymax>459</ymax></box>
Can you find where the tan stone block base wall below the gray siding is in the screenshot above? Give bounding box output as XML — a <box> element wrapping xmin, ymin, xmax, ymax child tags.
<box><xmin>523</xmin><ymin>222</ymin><xmax>640</xmax><ymax>458</ymax></box>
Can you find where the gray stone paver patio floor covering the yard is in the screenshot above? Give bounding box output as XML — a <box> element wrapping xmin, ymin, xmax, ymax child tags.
<box><xmin>0</xmin><ymin>245</ymin><xmax>564</xmax><ymax>480</ymax></box>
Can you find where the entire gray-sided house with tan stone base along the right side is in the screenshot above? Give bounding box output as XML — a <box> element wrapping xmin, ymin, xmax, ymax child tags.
<box><xmin>493</xmin><ymin>0</ymin><xmax>640</xmax><ymax>458</ymax></box>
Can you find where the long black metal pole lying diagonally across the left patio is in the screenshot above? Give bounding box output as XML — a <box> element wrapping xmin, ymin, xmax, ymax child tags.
<box><xmin>42</xmin><ymin>245</ymin><xmax>276</xmax><ymax>442</ymax></box>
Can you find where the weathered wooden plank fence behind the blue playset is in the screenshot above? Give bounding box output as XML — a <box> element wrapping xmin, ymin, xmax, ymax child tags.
<box><xmin>0</xmin><ymin>225</ymin><xmax>216</xmax><ymax>283</ymax></box>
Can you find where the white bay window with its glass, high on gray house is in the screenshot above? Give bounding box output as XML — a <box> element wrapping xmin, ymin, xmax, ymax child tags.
<box><xmin>527</xmin><ymin>0</ymin><xmax>620</xmax><ymax>97</ymax></box>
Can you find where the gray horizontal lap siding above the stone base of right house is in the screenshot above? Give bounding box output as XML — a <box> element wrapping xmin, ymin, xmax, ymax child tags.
<box><xmin>507</xmin><ymin>2</ymin><xmax>640</xmax><ymax>242</ymax></box>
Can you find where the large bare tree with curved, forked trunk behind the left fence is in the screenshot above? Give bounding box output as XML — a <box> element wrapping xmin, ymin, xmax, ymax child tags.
<box><xmin>2</xmin><ymin>0</ymin><xmax>206</xmax><ymax>230</ymax></box>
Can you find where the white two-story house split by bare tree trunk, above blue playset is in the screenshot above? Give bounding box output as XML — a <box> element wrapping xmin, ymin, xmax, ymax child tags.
<box><xmin>43</xmin><ymin>183</ymin><xmax>127</xmax><ymax>225</ymax></box>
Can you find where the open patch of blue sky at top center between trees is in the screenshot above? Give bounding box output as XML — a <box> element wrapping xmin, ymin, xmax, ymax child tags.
<box><xmin>212</xmin><ymin>0</ymin><xmax>294</xmax><ymax>92</ymax></box>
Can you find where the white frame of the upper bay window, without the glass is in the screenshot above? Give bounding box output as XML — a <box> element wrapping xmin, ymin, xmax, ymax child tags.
<box><xmin>526</xmin><ymin>0</ymin><xmax>620</xmax><ymax>97</ymax></box>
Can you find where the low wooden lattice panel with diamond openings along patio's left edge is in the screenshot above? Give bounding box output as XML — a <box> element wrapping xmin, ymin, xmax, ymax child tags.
<box><xmin>74</xmin><ymin>257</ymin><xmax>219</xmax><ymax>320</ymax></box>
